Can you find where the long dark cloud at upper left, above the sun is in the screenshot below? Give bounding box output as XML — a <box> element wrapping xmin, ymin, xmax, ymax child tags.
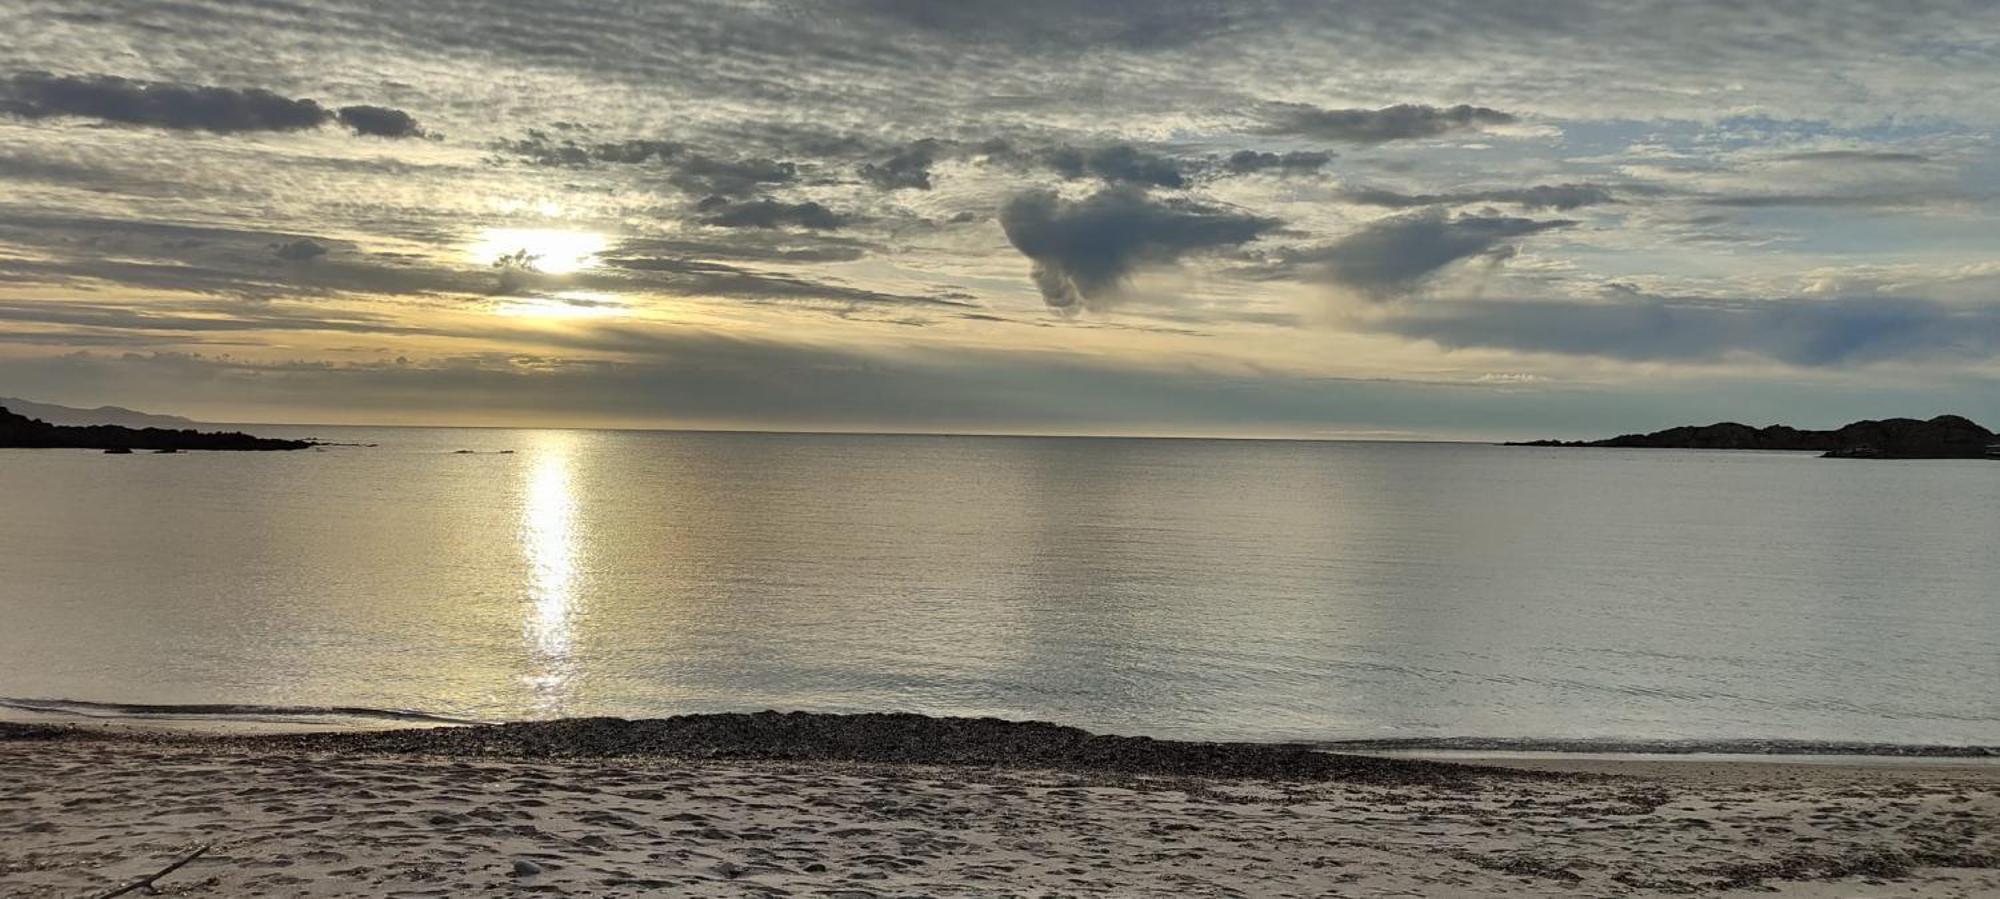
<box><xmin>0</xmin><ymin>72</ymin><xmax>420</xmax><ymax>138</ymax></box>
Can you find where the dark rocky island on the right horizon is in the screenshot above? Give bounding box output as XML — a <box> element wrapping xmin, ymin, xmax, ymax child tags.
<box><xmin>1508</xmin><ymin>416</ymin><xmax>2000</xmax><ymax>459</ymax></box>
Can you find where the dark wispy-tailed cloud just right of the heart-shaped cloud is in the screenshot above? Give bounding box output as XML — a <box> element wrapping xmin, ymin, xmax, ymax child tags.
<box><xmin>1282</xmin><ymin>210</ymin><xmax>1576</xmax><ymax>298</ymax></box>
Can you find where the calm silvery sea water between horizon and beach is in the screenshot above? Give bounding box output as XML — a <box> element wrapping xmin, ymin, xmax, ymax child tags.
<box><xmin>0</xmin><ymin>428</ymin><xmax>2000</xmax><ymax>743</ymax></box>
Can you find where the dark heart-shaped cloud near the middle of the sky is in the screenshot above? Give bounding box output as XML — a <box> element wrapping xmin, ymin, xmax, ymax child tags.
<box><xmin>1000</xmin><ymin>188</ymin><xmax>1278</xmax><ymax>310</ymax></box>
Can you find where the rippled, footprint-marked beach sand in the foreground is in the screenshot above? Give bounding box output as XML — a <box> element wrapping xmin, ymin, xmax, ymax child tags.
<box><xmin>0</xmin><ymin>727</ymin><xmax>2000</xmax><ymax>899</ymax></box>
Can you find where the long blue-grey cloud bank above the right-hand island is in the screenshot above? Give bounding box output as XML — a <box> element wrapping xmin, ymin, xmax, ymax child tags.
<box><xmin>1380</xmin><ymin>292</ymin><xmax>2000</xmax><ymax>368</ymax></box>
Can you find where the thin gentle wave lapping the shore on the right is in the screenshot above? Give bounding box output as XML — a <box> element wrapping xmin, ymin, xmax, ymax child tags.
<box><xmin>1312</xmin><ymin>737</ymin><xmax>2000</xmax><ymax>759</ymax></box>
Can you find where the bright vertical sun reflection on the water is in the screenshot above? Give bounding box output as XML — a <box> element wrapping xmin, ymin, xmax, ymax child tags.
<box><xmin>520</xmin><ymin>432</ymin><xmax>580</xmax><ymax>713</ymax></box>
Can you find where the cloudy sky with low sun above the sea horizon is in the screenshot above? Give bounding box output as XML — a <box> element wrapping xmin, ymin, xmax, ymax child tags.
<box><xmin>0</xmin><ymin>0</ymin><xmax>2000</xmax><ymax>440</ymax></box>
